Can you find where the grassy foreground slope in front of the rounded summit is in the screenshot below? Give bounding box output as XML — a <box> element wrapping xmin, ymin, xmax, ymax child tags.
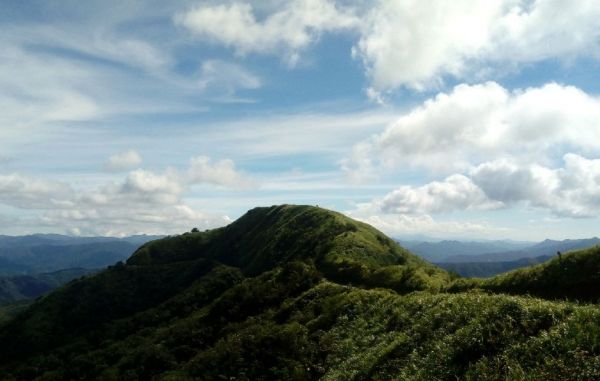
<box><xmin>4</xmin><ymin>268</ymin><xmax>600</xmax><ymax>381</ymax></box>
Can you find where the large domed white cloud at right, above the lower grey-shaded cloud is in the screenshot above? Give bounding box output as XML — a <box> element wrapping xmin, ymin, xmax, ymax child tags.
<box><xmin>342</xmin><ymin>82</ymin><xmax>600</xmax><ymax>179</ymax></box>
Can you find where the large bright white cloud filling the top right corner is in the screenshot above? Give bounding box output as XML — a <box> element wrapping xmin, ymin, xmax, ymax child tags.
<box><xmin>354</xmin><ymin>0</ymin><xmax>600</xmax><ymax>94</ymax></box>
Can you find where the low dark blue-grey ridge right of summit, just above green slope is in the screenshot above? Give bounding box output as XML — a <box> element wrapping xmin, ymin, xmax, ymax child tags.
<box><xmin>435</xmin><ymin>255</ymin><xmax>552</xmax><ymax>278</ymax></box>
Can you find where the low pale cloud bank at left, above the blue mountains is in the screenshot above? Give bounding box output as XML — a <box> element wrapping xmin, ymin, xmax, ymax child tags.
<box><xmin>0</xmin><ymin>156</ymin><xmax>255</xmax><ymax>235</ymax></box>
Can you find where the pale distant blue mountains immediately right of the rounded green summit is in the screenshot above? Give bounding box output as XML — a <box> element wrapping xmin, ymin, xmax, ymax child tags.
<box><xmin>399</xmin><ymin>240</ymin><xmax>533</xmax><ymax>262</ymax></box>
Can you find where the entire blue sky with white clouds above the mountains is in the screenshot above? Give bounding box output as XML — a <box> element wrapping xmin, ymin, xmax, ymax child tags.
<box><xmin>0</xmin><ymin>0</ymin><xmax>600</xmax><ymax>240</ymax></box>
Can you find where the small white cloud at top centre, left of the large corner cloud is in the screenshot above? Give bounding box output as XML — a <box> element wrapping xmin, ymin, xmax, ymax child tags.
<box><xmin>175</xmin><ymin>0</ymin><xmax>357</xmax><ymax>66</ymax></box>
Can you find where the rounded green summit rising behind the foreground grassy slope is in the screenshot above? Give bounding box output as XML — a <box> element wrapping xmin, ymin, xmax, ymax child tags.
<box><xmin>127</xmin><ymin>205</ymin><xmax>448</xmax><ymax>291</ymax></box>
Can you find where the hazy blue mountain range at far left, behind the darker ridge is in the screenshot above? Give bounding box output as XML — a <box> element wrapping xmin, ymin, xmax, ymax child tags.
<box><xmin>0</xmin><ymin>234</ymin><xmax>160</xmax><ymax>275</ymax></box>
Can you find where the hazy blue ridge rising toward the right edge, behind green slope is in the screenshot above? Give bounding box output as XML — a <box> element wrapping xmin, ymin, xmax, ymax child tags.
<box><xmin>437</xmin><ymin>237</ymin><xmax>600</xmax><ymax>262</ymax></box>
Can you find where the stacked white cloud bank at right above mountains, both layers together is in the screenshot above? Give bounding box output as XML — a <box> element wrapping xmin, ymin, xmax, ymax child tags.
<box><xmin>342</xmin><ymin>82</ymin><xmax>600</xmax><ymax>218</ymax></box>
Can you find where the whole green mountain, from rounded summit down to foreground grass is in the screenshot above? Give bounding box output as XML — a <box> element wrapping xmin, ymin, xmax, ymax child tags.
<box><xmin>0</xmin><ymin>205</ymin><xmax>600</xmax><ymax>380</ymax></box>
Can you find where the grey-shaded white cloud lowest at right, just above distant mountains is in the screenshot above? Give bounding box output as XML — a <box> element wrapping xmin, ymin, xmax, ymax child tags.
<box><xmin>359</xmin><ymin>153</ymin><xmax>600</xmax><ymax>218</ymax></box>
